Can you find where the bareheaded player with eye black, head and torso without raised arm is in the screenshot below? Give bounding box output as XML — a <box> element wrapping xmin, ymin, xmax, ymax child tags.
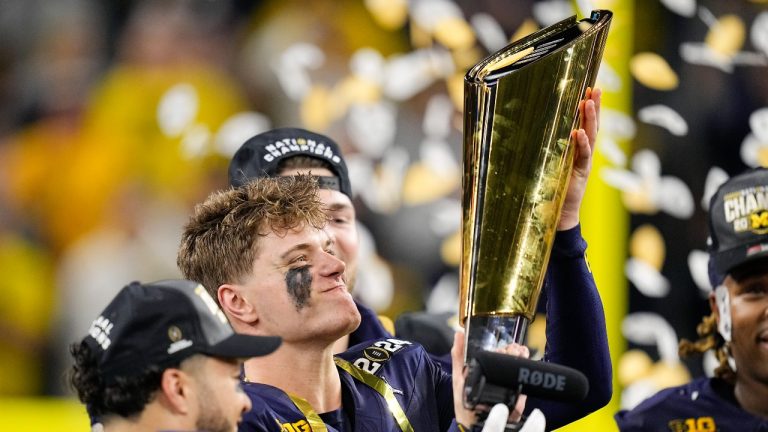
<box><xmin>177</xmin><ymin>175</ymin><xmax>527</xmax><ymax>432</ymax></box>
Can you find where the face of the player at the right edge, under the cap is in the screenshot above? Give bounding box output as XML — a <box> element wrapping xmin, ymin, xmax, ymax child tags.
<box><xmin>724</xmin><ymin>258</ymin><xmax>768</xmax><ymax>386</ymax></box>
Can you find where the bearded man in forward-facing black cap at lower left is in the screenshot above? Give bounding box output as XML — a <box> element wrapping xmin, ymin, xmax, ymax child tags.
<box><xmin>70</xmin><ymin>280</ymin><xmax>280</xmax><ymax>432</ymax></box>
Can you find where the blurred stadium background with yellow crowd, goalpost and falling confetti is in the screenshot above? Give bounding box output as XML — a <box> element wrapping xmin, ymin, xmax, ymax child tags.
<box><xmin>0</xmin><ymin>0</ymin><xmax>768</xmax><ymax>431</ymax></box>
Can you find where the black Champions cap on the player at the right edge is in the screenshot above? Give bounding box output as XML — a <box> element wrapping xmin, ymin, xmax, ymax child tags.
<box><xmin>708</xmin><ymin>168</ymin><xmax>768</xmax><ymax>288</ymax></box>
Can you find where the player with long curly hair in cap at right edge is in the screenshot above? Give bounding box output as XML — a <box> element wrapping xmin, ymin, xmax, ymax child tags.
<box><xmin>616</xmin><ymin>168</ymin><xmax>768</xmax><ymax>431</ymax></box>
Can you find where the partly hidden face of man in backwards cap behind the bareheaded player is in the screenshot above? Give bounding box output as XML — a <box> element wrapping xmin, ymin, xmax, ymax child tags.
<box><xmin>280</xmin><ymin>167</ymin><xmax>360</xmax><ymax>291</ymax></box>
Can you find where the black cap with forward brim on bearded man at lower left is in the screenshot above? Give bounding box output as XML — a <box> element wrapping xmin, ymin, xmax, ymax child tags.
<box><xmin>83</xmin><ymin>280</ymin><xmax>281</xmax><ymax>381</ymax></box>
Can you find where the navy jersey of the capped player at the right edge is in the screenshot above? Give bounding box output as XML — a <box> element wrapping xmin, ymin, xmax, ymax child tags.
<box><xmin>615</xmin><ymin>377</ymin><xmax>768</xmax><ymax>432</ymax></box>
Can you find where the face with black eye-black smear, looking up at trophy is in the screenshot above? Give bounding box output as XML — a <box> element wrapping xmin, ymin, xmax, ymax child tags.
<box><xmin>238</xmin><ymin>226</ymin><xmax>360</xmax><ymax>343</ymax></box>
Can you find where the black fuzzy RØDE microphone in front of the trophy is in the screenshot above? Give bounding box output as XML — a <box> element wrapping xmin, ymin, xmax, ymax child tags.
<box><xmin>466</xmin><ymin>350</ymin><xmax>589</xmax><ymax>406</ymax></box>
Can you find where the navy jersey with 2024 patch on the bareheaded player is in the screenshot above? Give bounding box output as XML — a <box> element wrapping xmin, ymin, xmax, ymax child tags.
<box><xmin>239</xmin><ymin>338</ymin><xmax>459</xmax><ymax>432</ymax></box>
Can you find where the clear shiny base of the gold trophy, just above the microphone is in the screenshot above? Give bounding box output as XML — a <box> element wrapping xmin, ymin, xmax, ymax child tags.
<box><xmin>466</xmin><ymin>315</ymin><xmax>528</xmax><ymax>362</ymax></box>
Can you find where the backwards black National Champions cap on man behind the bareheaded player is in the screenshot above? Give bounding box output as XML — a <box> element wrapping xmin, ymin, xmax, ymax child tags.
<box><xmin>229</xmin><ymin>128</ymin><xmax>352</xmax><ymax>198</ymax></box>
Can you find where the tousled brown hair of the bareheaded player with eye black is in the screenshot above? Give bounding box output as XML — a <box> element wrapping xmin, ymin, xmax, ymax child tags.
<box><xmin>176</xmin><ymin>175</ymin><xmax>327</xmax><ymax>303</ymax></box>
